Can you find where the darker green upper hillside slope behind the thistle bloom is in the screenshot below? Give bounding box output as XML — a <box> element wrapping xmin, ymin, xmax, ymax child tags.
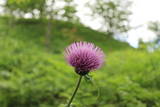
<box><xmin>0</xmin><ymin>18</ymin><xmax>131</xmax><ymax>52</ymax></box>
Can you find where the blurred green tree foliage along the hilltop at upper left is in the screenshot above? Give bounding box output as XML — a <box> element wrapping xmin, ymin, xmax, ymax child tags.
<box><xmin>5</xmin><ymin>0</ymin><xmax>79</xmax><ymax>22</ymax></box>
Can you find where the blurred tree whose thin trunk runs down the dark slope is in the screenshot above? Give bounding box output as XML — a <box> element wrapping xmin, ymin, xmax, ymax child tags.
<box><xmin>45</xmin><ymin>0</ymin><xmax>78</xmax><ymax>48</ymax></box>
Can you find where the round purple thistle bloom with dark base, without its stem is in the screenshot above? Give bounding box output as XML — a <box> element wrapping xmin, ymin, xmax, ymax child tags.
<box><xmin>65</xmin><ymin>42</ymin><xmax>105</xmax><ymax>75</ymax></box>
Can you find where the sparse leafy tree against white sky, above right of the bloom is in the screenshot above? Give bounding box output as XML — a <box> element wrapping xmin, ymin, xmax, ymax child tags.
<box><xmin>88</xmin><ymin>0</ymin><xmax>131</xmax><ymax>35</ymax></box>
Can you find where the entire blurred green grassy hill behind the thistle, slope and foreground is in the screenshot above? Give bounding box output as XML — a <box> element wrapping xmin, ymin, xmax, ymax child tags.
<box><xmin>0</xmin><ymin>18</ymin><xmax>160</xmax><ymax>107</ymax></box>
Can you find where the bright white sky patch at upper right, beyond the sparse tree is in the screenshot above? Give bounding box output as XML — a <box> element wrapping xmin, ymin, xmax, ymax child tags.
<box><xmin>128</xmin><ymin>0</ymin><xmax>160</xmax><ymax>47</ymax></box>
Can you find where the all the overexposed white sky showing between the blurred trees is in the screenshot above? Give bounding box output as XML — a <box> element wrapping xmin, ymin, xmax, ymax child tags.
<box><xmin>0</xmin><ymin>0</ymin><xmax>160</xmax><ymax>48</ymax></box>
